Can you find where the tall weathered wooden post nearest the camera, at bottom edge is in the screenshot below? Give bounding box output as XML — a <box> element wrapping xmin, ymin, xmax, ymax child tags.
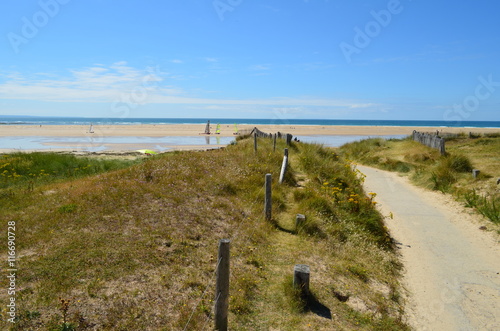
<box><xmin>214</xmin><ymin>239</ymin><xmax>231</xmax><ymax>331</ymax></box>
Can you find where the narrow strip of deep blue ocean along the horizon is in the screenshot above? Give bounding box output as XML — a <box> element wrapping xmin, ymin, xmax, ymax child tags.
<box><xmin>0</xmin><ymin>115</ymin><xmax>500</xmax><ymax>128</ymax></box>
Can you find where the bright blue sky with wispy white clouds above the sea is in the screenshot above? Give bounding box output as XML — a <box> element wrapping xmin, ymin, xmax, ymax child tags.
<box><xmin>0</xmin><ymin>0</ymin><xmax>500</xmax><ymax>121</ymax></box>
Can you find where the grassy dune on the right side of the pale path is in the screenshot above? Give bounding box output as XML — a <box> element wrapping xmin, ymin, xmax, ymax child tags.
<box><xmin>340</xmin><ymin>133</ymin><xmax>500</xmax><ymax>224</ymax></box>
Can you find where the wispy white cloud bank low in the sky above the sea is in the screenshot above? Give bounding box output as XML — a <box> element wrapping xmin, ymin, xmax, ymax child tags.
<box><xmin>0</xmin><ymin>61</ymin><xmax>377</xmax><ymax>111</ymax></box>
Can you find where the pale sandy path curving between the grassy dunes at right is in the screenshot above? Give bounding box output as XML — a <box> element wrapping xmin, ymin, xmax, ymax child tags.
<box><xmin>358</xmin><ymin>166</ymin><xmax>500</xmax><ymax>330</ymax></box>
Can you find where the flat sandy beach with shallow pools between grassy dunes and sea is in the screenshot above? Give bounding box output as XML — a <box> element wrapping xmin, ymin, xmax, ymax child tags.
<box><xmin>0</xmin><ymin>124</ymin><xmax>500</xmax><ymax>152</ymax></box>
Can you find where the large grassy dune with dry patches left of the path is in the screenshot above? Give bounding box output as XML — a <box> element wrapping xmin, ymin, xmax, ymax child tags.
<box><xmin>0</xmin><ymin>139</ymin><xmax>407</xmax><ymax>330</ymax></box>
